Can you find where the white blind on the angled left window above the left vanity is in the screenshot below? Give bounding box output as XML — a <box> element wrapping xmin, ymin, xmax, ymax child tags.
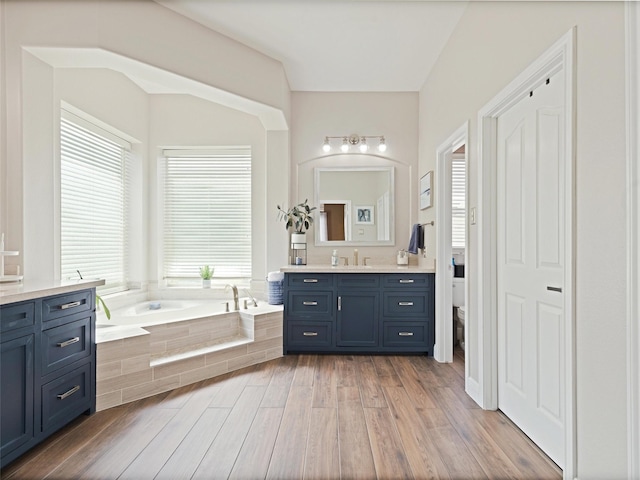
<box><xmin>60</xmin><ymin>110</ymin><xmax>131</xmax><ymax>294</ymax></box>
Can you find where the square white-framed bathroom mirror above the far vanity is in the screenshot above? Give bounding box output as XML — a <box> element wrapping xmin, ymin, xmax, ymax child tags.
<box><xmin>314</xmin><ymin>167</ymin><xmax>395</xmax><ymax>246</ymax></box>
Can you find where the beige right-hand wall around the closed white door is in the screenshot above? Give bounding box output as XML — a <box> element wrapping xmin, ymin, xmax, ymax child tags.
<box><xmin>420</xmin><ymin>2</ymin><xmax>627</xmax><ymax>479</ymax></box>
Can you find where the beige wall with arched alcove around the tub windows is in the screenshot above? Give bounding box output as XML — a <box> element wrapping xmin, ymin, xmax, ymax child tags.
<box><xmin>0</xmin><ymin>0</ymin><xmax>290</xmax><ymax>282</ymax></box>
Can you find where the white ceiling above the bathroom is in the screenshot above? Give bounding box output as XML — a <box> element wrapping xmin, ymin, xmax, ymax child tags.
<box><xmin>156</xmin><ymin>0</ymin><xmax>467</xmax><ymax>92</ymax></box>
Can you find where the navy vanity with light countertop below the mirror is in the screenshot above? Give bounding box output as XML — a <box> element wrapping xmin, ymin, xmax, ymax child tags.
<box><xmin>281</xmin><ymin>265</ymin><xmax>435</xmax><ymax>355</ymax></box>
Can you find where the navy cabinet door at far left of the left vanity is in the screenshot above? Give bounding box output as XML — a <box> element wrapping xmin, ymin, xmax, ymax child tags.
<box><xmin>0</xmin><ymin>334</ymin><xmax>35</xmax><ymax>457</ymax></box>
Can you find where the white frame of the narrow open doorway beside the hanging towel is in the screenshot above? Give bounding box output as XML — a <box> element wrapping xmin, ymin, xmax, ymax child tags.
<box><xmin>433</xmin><ymin>121</ymin><xmax>469</xmax><ymax>364</ymax></box>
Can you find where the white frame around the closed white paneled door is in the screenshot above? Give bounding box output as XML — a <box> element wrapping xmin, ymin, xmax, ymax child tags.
<box><xmin>470</xmin><ymin>27</ymin><xmax>577</xmax><ymax>478</ymax></box>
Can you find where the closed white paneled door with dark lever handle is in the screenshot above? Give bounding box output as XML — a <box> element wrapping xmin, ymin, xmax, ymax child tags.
<box><xmin>497</xmin><ymin>72</ymin><xmax>565</xmax><ymax>467</ymax></box>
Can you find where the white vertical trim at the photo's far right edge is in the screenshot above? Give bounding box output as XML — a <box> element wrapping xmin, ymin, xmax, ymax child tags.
<box><xmin>625</xmin><ymin>2</ymin><xmax>640</xmax><ymax>478</ymax></box>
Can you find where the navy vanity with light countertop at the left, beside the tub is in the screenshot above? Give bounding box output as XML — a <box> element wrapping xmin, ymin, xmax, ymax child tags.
<box><xmin>0</xmin><ymin>280</ymin><xmax>104</xmax><ymax>467</ymax></box>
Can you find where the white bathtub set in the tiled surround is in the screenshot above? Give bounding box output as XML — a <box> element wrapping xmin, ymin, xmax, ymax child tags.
<box><xmin>97</xmin><ymin>300</ymin><xmax>233</xmax><ymax>328</ymax></box>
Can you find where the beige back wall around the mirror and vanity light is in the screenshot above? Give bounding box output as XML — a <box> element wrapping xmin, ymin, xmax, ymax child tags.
<box><xmin>292</xmin><ymin>92</ymin><xmax>419</xmax><ymax>265</ymax></box>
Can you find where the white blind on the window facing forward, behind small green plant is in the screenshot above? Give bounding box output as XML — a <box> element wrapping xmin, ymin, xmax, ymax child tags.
<box><xmin>163</xmin><ymin>147</ymin><xmax>251</xmax><ymax>285</ymax></box>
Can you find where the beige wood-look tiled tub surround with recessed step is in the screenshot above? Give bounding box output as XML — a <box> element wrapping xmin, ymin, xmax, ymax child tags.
<box><xmin>96</xmin><ymin>302</ymin><xmax>283</xmax><ymax>411</ymax></box>
